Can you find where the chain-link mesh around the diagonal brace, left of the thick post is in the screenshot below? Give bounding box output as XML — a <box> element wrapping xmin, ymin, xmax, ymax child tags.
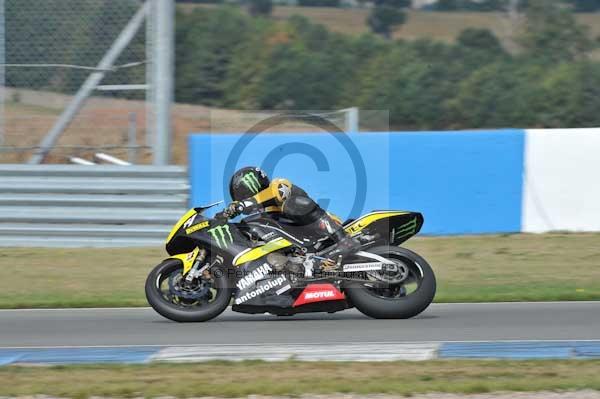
<box><xmin>0</xmin><ymin>0</ymin><xmax>152</xmax><ymax>163</ymax></box>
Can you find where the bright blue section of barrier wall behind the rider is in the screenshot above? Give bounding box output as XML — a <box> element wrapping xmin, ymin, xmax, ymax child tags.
<box><xmin>189</xmin><ymin>130</ymin><xmax>525</xmax><ymax>234</ymax></box>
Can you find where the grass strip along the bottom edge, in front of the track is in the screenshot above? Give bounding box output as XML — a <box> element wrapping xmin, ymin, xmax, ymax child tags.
<box><xmin>0</xmin><ymin>360</ymin><xmax>600</xmax><ymax>398</ymax></box>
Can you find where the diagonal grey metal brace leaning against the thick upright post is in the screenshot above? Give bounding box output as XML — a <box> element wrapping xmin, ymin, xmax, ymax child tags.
<box><xmin>29</xmin><ymin>3</ymin><xmax>148</xmax><ymax>164</ymax></box>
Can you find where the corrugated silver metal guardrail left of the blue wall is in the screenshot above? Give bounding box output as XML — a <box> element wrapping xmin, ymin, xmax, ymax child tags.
<box><xmin>0</xmin><ymin>165</ymin><xmax>189</xmax><ymax>247</ymax></box>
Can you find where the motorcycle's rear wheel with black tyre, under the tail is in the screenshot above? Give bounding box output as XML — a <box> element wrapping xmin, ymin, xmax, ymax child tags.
<box><xmin>346</xmin><ymin>246</ymin><xmax>436</xmax><ymax>319</ymax></box>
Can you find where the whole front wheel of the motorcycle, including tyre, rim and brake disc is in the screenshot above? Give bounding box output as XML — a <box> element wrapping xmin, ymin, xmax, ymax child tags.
<box><xmin>146</xmin><ymin>259</ymin><xmax>232</xmax><ymax>322</ymax></box>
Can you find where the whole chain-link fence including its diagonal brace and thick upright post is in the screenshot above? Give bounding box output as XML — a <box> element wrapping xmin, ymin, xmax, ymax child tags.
<box><xmin>0</xmin><ymin>0</ymin><xmax>174</xmax><ymax>164</ymax></box>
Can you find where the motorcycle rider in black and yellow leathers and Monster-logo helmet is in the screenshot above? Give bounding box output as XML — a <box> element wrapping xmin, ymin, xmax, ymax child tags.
<box><xmin>223</xmin><ymin>166</ymin><xmax>360</xmax><ymax>266</ymax></box>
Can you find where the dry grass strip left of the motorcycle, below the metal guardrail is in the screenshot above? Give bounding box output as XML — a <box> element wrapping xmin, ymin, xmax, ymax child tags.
<box><xmin>0</xmin><ymin>248</ymin><xmax>166</xmax><ymax>308</ymax></box>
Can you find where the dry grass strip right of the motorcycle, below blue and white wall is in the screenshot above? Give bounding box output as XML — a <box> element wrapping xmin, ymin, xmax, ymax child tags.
<box><xmin>406</xmin><ymin>233</ymin><xmax>600</xmax><ymax>302</ymax></box>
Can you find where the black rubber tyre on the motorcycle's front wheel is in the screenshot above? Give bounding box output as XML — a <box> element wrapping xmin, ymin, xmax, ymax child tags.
<box><xmin>146</xmin><ymin>259</ymin><xmax>232</xmax><ymax>322</ymax></box>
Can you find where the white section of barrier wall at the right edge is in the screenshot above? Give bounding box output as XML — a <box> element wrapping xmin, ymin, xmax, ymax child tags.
<box><xmin>521</xmin><ymin>128</ymin><xmax>600</xmax><ymax>233</ymax></box>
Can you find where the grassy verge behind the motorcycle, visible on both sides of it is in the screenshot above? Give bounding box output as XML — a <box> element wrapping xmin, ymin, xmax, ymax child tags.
<box><xmin>0</xmin><ymin>234</ymin><xmax>600</xmax><ymax>308</ymax></box>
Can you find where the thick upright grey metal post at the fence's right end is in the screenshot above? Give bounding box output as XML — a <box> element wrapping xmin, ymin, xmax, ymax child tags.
<box><xmin>152</xmin><ymin>0</ymin><xmax>175</xmax><ymax>165</ymax></box>
